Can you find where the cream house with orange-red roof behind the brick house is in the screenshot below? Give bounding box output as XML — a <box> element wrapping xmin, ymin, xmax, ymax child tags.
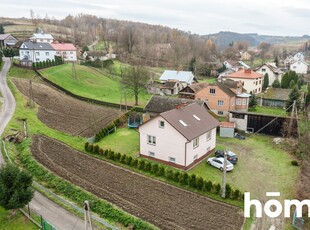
<box><xmin>222</xmin><ymin>69</ymin><xmax>263</xmax><ymax>94</ymax></box>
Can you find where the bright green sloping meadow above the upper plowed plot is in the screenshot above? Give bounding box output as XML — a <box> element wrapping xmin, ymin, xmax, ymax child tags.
<box><xmin>40</xmin><ymin>64</ymin><xmax>151</xmax><ymax>106</ymax></box>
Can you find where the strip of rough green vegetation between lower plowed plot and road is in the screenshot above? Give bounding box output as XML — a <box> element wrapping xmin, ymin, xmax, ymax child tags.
<box><xmin>18</xmin><ymin>139</ymin><xmax>156</xmax><ymax>229</ymax></box>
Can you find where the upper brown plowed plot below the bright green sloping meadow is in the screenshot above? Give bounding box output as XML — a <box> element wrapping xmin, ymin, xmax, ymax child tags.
<box><xmin>13</xmin><ymin>79</ymin><xmax>120</xmax><ymax>137</ymax></box>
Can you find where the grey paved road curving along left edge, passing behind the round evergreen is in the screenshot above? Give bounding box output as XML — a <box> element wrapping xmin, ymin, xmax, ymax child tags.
<box><xmin>0</xmin><ymin>58</ymin><xmax>85</xmax><ymax>230</ymax></box>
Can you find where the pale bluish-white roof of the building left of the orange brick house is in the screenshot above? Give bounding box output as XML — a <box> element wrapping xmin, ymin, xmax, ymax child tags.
<box><xmin>159</xmin><ymin>70</ymin><xmax>197</xmax><ymax>86</ymax></box>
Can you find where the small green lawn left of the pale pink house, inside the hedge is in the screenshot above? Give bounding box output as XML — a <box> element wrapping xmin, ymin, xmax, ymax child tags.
<box><xmin>97</xmin><ymin>127</ymin><xmax>139</xmax><ymax>157</ymax></box>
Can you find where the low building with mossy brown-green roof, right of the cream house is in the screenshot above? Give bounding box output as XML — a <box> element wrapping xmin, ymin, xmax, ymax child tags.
<box><xmin>256</xmin><ymin>87</ymin><xmax>292</xmax><ymax>108</ymax></box>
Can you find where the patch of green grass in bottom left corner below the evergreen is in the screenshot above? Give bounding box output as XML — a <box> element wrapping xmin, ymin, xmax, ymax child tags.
<box><xmin>0</xmin><ymin>207</ymin><xmax>38</xmax><ymax>230</ymax></box>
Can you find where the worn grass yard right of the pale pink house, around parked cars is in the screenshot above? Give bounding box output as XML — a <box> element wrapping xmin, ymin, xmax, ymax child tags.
<box><xmin>190</xmin><ymin>134</ymin><xmax>299</xmax><ymax>200</ymax></box>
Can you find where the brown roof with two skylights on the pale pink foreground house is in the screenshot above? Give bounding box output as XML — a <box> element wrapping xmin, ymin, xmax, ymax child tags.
<box><xmin>160</xmin><ymin>103</ymin><xmax>219</xmax><ymax>141</ymax></box>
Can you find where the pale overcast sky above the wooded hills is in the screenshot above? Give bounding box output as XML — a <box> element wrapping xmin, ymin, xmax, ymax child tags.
<box><xmin>0</xmin><ymin>0</ymin><xmax>310</xmax><ymax>36</ymax></box>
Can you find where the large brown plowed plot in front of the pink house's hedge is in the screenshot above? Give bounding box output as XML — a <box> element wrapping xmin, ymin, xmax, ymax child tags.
<box><xmin>31</xmin><ymin>136</ymin><xmax>243</xmax><ymax>230</ymax></box>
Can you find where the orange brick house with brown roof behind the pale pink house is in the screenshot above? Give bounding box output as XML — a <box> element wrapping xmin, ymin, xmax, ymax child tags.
<box><xmin>179</xmin><ymin>80</ymin><xmax>250</xmax><ymax>116</ymax></box>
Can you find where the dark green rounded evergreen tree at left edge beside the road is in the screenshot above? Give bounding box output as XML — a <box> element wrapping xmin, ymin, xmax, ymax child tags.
<box><xmin>0</xmin><ymin>164</ymin><xmax>34</xmax><ymax>210</ymax></box>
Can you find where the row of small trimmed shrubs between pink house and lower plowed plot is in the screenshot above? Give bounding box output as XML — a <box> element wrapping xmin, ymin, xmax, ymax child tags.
<box><xmin>84</xmin><ymin>142</ymin><xmax>243</xmax><ymax>200</ymax></box>
